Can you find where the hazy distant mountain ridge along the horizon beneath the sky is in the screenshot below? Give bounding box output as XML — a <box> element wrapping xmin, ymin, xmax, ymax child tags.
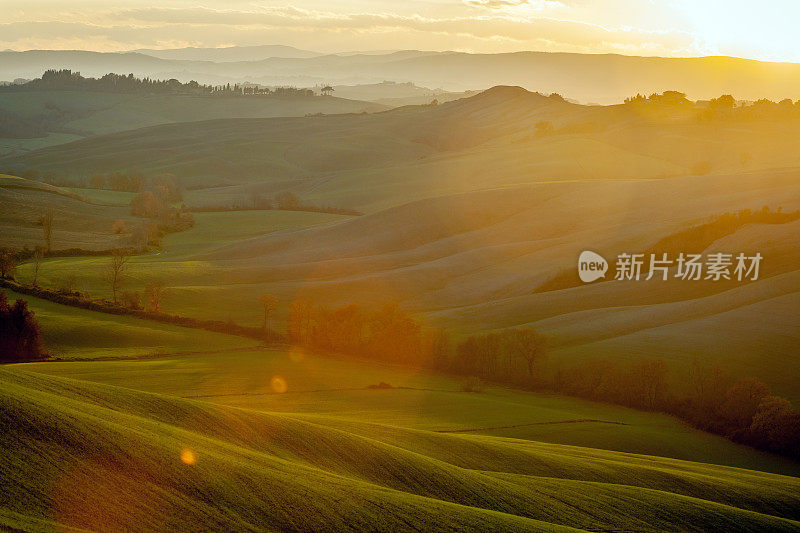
<box><xmin>0</xmin><ymin>47</ymin><xmax>800</xmax><ymax>104</ymax></box>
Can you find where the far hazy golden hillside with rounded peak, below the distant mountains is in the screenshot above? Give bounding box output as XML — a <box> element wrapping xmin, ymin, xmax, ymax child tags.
<box><xmin>6</xmin><ymin>87</ymin><xmax>800</xmax><ymax>200</ymax></box>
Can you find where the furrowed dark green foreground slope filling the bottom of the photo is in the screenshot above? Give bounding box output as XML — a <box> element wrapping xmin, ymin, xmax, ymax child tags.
<box><xmin>0</xmin><ymin>370</ymin><xmax>800</xmax><ymax>531</ymax></box>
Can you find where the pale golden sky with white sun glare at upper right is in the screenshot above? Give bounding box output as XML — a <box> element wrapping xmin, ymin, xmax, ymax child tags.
<box><xmin>0</xmin><ymin>0</ymin><xmax>800</xmax><ymax>62</ymax></box>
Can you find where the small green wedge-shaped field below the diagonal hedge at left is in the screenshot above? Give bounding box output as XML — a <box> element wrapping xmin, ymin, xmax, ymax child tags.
<box><xmin>0</xmin><ymin>289</ymin><xmax>253</xmax><ymax>359</ymax></box>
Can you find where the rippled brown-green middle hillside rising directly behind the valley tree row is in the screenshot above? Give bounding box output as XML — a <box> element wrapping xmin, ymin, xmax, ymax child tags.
<box><xmin>14</xmin><ymin>177</ymin><xmax>800</xmax><ymax>401</ymax></box>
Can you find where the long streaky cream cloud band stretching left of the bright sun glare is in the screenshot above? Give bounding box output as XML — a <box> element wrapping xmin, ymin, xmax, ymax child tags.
<box><xmin>0</xmin><ymin>5</ymin><xmax>697</xmax><ymax>55</ymax></box>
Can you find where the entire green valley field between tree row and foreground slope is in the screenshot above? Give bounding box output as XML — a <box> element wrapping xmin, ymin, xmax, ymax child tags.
<box><xmin>7</xmin><ymin>266</ymin><xmax>800</xmax><ymax>475</ymax></box>
